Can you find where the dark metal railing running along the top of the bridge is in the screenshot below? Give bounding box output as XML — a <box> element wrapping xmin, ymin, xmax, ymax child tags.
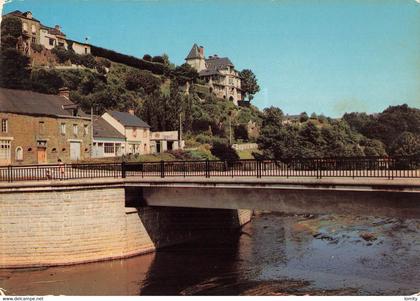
<box><xmin>0</xmin><ymin>156</ymin><xmax>420</xmax><ymax>182</ymax></box>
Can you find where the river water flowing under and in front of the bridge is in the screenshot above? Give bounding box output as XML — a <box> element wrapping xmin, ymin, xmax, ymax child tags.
<box><xmin>0</xmin><ymin>213</ymin><xmax>420</xmax><ymax>295</ymax></box>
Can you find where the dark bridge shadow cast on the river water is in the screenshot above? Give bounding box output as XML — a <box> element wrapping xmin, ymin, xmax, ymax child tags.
<box><xmin>140</xmin><ymin>231</ymin><xmax>240</xmax><ymax>295</ymax></box>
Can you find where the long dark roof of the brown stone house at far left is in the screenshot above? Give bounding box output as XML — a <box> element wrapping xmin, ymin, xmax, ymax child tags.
<box><xmin>0</xmin><ymin>88</ymin><xmax>88</xmax><ymax>117</ymax></box>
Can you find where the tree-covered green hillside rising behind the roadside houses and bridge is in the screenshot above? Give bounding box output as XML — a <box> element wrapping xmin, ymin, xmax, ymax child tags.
<box><xmin>0</xmin><ymin>17</ymin><xmax>420</xmax><ymax>158</ymax></box>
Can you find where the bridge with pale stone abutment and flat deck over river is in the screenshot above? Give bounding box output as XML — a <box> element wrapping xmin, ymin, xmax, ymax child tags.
<box><xmin>0</xmin><ymin>177</ymin><xmax>420</xmax><ymax>267</ymax></box>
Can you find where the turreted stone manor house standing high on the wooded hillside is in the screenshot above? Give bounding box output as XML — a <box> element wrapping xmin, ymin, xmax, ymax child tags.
<box><xmin>185</xmin><ymin>44</ymin><xmax>243</xmax><ymax>105</ymax></box>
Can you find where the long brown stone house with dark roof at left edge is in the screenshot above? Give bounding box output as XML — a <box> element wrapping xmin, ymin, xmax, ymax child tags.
<box><xmin>0</xmin><ymin>88</ymin><xmax>92</xmax><ymax>165</ymax></box>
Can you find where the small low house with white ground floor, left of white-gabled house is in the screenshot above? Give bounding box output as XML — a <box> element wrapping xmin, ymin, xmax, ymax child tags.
<box><xmin>92</xmin><ymin>116</ymin><xmax>125</xmax><ymax>158</ymax></box>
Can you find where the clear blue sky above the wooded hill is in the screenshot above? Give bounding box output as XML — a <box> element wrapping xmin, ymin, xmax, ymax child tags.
<box><xmin>3</xmin><ymin>0</ymin><xmax>420</xmax><ymax>117</ymax></box>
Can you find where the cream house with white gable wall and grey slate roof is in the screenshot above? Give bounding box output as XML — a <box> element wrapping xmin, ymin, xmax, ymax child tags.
<box><xmin>102</xmin><ymin>110</ymin><xmax>150</xmax><ymax>155</ymax></box>
